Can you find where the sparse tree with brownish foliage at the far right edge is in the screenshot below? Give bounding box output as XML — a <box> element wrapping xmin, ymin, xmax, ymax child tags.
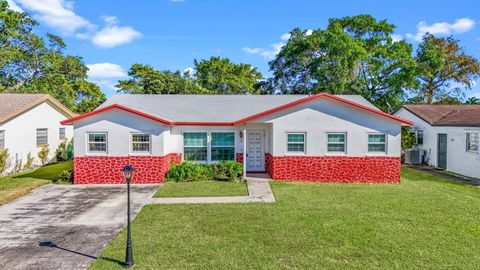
<box><xmin>414</xmin><ymin>34</ymin><xmax>480</xmax><ymax>104</ymax></box>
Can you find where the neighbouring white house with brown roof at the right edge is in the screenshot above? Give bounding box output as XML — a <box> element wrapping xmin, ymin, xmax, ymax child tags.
<box><xmin>395</xmin><ymin>105</ymin><xmax>480</xmax><ymax>178</ymax></box>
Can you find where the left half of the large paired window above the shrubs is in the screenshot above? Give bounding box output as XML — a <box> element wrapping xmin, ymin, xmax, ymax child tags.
<box><xmin>183</xmin><ymin>132</ymin><xmax>208</xmax><ymax>162</ymax></box>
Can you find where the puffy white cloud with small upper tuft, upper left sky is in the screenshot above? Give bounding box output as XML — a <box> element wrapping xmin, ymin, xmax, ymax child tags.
<box><xmin>92</xmin><ymin>16</ymin><xmax>141</xmax><ymax>48</ymax></box>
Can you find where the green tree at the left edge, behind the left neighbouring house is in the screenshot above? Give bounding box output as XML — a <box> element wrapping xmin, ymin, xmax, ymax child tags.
<box><xmin>0</xmin><ymin>0</ymin><xmax>105</xmax><ymax>113</ymax></box>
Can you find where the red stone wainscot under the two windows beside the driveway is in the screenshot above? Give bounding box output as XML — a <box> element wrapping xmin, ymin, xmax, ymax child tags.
<box><xmin>73</xmin><ymin>153</ymin><xmax>182</xmax><ymax>184</ymax></box>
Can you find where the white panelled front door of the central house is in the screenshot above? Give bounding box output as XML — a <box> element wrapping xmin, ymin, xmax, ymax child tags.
<box><xmin>247</xmin><ymin>130</ymin><xmax>265</xmax><ymax>172</ymax></box>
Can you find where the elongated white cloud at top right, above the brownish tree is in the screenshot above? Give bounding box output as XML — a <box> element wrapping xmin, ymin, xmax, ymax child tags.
<box><xmin>407</xmin><ymin>18</ymin><xmax>475</xmax><ymax>41</ymax></box>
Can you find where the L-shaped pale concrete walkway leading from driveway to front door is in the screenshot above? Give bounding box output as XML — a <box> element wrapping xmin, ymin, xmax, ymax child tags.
<box><xmin>147</xmin><ymin>174</ymin><xmax>275</xmax><ymax>204</ymax></box>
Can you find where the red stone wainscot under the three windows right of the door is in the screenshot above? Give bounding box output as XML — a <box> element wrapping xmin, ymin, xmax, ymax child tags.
<box><xmin>266</xmin><ymin>154</ymin><xmax>400</xmax><ymax>183</ymax></box>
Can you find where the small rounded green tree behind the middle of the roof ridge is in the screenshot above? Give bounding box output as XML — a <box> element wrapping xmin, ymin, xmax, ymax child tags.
<box><xmin>194</xmin><ymin>57</ymin><xmax>263</xmax><ymax>94</ymax></box>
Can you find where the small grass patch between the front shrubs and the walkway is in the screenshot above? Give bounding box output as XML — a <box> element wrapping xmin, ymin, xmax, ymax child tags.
<box><xmin>154</xmin><ymin>181</ymin><xmax>248</xmax><ymax>197</ymax></box>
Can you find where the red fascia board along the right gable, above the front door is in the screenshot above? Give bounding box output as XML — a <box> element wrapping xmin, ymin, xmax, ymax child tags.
<box><xmin>233</xmin><ymin>93</ymin><xmax>413</xmax><ymax>126</ymax></box>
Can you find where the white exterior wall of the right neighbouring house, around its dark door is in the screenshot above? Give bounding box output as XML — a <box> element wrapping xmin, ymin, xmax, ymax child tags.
<box><xmin>395</xmin><ymin>108</ymin><xmax>480</xmax><ymax>178</ymax></box>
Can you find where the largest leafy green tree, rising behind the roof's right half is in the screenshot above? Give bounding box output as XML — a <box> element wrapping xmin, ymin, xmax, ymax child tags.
<box><xmin>270</xmin><ymin>15</ymin><xmax>417</xmax><ymax>111</ymax></box>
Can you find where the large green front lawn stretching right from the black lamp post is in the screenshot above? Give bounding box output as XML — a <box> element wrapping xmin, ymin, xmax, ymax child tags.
<box><xmin>91</xmin><ymin>168</ymin><xmax>480</xmax><ymax>269</ymax></box>
